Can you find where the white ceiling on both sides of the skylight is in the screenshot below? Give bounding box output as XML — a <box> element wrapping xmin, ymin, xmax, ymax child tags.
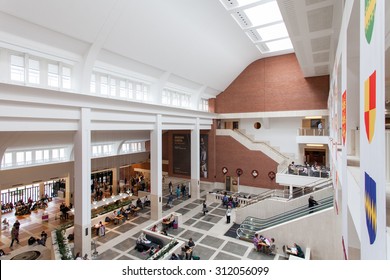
<box><xmin>0</xmin><ymin>0</ymin><xmax>341</xmax><ymax>96</ymax></box>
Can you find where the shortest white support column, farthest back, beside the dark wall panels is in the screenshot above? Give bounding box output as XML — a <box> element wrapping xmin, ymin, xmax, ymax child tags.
<box><xmin>189</xmin><ymin>119</ymin><xmax>200</xmax><ymax>199</ymax></box>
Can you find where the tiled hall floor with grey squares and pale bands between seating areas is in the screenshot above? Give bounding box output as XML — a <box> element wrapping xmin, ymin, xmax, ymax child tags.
<box><xmin>1</xmin><ymin>180</ymin><xmax>282</xmax><ymax>260</ymax></box>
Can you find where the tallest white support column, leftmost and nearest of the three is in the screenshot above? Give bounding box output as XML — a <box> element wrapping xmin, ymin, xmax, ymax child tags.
<box><xmin>74</xmin><ymin>108</ymin><xmax>91</xmax><ymax>256</ymax></box>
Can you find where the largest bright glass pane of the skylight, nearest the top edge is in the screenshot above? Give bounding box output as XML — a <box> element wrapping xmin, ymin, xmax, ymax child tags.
<box><xmin>244</xmin><ymin>1</ymin><xmax>283</xmax><ymax>26</ymax></box>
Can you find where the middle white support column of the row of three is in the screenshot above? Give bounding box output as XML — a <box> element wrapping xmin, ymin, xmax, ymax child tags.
<box><xmin>150</xmin><ymin>115</ymin><xmax>162</xmax><ymax>220</ymax></box>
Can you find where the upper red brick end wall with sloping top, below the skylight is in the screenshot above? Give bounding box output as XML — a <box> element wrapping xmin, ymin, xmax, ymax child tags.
<box><xmin>215</xmin><ymin>54</ymin><xmax>329</xmax><ymax>113</ymax></box>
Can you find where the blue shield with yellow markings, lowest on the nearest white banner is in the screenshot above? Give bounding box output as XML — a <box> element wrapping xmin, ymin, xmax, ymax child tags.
<box><xmin>364</xmin><ymin>172</ymin><xmax>377</xmax><ymax>244</ymax></box>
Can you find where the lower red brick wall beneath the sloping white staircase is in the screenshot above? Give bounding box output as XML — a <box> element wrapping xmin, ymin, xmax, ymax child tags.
<box><xmin>216</xmin><ymin>136</ymin><xmax>280</xmax><ymax>189</ymax></box>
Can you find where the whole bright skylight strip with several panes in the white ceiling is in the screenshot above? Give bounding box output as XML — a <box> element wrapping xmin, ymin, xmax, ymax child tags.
<box><xmin>220</xmin><ymin>0</ymin><xmax>293</xmax><ymax>54</ymax></box>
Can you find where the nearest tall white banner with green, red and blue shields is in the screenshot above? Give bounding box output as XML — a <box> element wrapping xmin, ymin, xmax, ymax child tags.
<box><xmin>360</xmin><ymin>0</ymin><xmax>387</xmax><ymax>259</ymax></box>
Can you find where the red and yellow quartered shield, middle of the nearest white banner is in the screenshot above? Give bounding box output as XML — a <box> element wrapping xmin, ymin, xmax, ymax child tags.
<box><xmin>364</xmin><ymin>71</ymin><xmax>376</xmax><ymax>143</ymax></box>
